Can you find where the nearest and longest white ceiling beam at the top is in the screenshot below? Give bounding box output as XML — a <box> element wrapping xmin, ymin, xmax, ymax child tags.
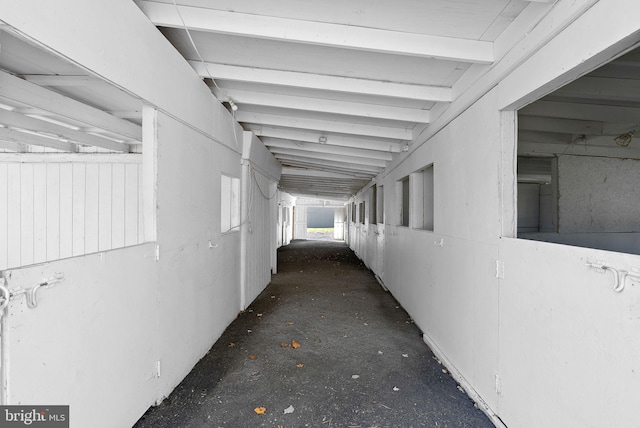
<box><xmin>137</xmin><ymin>0</ymin><xmax>494</xmax><ymax>64</ymax></box>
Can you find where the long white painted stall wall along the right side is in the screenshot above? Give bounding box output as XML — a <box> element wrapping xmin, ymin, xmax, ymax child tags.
<box><xmin>349</xmin><ymin>0</ymin><xmax>640</xmax><ymax>428</ymax></box>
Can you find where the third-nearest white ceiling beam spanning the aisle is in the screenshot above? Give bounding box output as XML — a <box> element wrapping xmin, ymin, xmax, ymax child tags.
<box><xmin>212</xmin><ymin>88</ymin><xmax>429</xmax><ymax>123</ymax></box>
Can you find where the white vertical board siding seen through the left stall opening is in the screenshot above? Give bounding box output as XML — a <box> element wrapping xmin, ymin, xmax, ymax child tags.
<box><xmin>0</xmin><ymin>162</ymin><xmax>143</xmax><ymax>269</ymax></box>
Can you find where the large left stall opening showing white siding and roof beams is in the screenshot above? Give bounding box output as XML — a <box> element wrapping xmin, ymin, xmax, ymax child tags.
<box><xmin>0</xmin><ymin>31</ymin><xmax>149</xmax><ymax>270</ymax></box>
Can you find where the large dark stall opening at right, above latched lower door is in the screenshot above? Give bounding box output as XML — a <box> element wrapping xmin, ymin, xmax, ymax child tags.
<box><xmin>517</xmin><ymin>45</ymin><xmax>640</xmax><ymax>254</ymax></box>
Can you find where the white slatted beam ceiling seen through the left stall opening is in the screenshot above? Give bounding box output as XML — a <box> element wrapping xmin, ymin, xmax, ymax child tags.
<box><xmin>0</xmin><ymin>27</ymin><xmax>142</xmax><ymax>154</ymax></box>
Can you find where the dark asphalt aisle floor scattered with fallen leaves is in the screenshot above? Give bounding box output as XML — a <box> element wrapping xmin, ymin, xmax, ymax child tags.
<box><xmin>135</xmin><ymin>241</ymin><xmax>493</xmax><ymax>428</ymax></box>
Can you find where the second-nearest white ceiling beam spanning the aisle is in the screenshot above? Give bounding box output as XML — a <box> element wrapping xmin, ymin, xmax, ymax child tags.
<box><xmin>189</xmin><ymin>61</ymin><xmax>452</xmax><ymax>102</ymax></box>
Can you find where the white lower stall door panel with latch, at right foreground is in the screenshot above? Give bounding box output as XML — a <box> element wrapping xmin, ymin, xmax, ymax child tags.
<box><xmin>499</xmin><ymin>238</ymin><xmax>640</xmax><ymax>428</ymax></box>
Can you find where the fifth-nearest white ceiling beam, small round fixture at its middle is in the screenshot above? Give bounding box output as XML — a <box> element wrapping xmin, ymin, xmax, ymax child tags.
<box><xmin>247</xmin><ymin>125</ymin><xmax>402</xmax><ymax>153</ymax></box>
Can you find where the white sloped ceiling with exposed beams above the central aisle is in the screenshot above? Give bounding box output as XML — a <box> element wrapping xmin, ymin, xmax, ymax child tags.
<box><xmin>135</xmin><ymin>0</ymin><xmax>551</xmax><ymax>200</ymax></box>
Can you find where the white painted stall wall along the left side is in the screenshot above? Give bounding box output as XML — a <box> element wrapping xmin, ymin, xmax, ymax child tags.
<box><xmin>2</xmin><ymin>0</ymin><xmax>275</xmax><ymax>427</ymax></box>
